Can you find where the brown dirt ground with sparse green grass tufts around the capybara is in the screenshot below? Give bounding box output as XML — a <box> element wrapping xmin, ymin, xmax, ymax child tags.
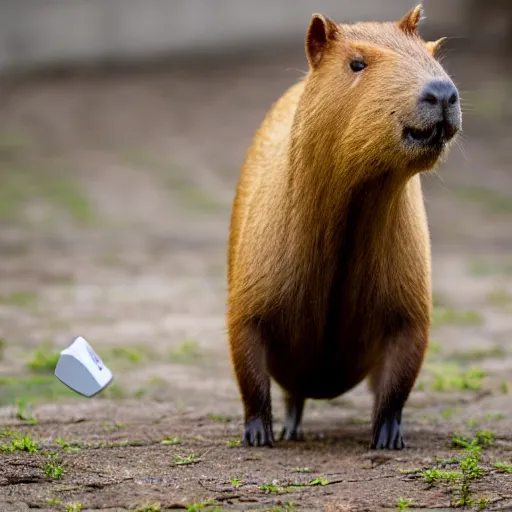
<box><xmin>0</xmin><ymin>45</ymin><xmax>512</xmax><ymax>512</ymax></box>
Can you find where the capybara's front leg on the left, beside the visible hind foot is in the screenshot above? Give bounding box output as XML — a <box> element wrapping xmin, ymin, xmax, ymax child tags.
<box><xmin>229</xmin><ymin>324</ymin><xmax>274</xmax><ymax>446</ymax></box>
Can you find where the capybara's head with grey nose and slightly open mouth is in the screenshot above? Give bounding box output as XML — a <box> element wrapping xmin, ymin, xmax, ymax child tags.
<box><xmin>297</xmin><ymin>5</ymin><xmax>461</xmax><ymax>173</ymax></box>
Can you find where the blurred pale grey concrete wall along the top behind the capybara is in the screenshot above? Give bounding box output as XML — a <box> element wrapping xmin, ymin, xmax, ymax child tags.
<box><xmin>0</xmin><ymin>0</ymin><xmax>464</xmax><ymax>71</ymax></box>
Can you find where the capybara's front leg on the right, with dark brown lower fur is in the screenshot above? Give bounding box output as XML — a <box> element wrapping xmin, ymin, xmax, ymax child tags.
<box><xmin>371</xmin><ymin>329</ymin><xmax>428</xmax><ymax>450</ymax></box>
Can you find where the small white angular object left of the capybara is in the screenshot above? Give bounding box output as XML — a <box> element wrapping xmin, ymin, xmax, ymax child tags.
<box><xmin>55</xmin><ymin>336</ymin><xmax>113</xmax><ymax>397</ymax></box>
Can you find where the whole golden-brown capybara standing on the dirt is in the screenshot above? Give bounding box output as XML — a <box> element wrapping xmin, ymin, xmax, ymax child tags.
<box><xmin>228</xmin><ymin>8</ymin><xmax>460</xmax><ymax>448</ymax></box>
